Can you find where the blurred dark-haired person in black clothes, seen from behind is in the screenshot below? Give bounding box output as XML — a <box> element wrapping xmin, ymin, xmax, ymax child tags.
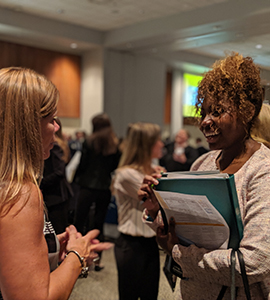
<box><xmin>73</xmin><ymin>113</ymin><xmax>121</xmax><ymax>271</ymax></box>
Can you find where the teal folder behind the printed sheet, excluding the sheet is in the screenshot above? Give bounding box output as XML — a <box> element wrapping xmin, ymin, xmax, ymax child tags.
<box><xmin>155</xmin><ymin>172</ymin><xmax>243</xmax><ymax>250</ymax></box>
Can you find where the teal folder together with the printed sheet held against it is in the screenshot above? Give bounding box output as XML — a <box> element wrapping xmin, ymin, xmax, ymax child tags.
<box><xmin>155</xmin><ymin>172</ymin><xmax>243</xmax><ymax>249</ymax></box>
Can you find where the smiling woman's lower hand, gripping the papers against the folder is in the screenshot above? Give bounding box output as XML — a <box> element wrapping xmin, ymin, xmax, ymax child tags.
<box><xmin>156</xmin><ymin>217</ymin><xmax>179</xmax><ymax>255</ymax></box>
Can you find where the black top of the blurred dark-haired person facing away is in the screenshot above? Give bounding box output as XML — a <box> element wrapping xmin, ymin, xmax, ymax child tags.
<box><xmin>73</xmin><ymin>141</ymin><xmax>121</xmax><ymax>190</ymax></box>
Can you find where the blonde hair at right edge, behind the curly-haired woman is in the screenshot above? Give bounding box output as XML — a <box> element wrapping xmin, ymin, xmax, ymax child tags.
<box><xmin>251</xmin><ymin>103</ymin><xmax>270</xmax><ymax>148</ymax></box>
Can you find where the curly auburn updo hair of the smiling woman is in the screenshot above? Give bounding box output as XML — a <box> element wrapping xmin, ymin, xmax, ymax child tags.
<box><xmin>196</xmin><ymin>52</ymin><xmax>263</xmax><ymax>136</ymax></box>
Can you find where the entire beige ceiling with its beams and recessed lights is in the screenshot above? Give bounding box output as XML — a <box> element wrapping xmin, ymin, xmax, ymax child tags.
<box><xmin>0</xmin><ymin>0</ymin><xmax>270</xmax><ymax>82</ymax></box>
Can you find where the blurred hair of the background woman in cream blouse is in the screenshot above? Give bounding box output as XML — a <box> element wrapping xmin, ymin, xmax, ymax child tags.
<box><xmin>119</xmin><ymin>122</ymin><xmax>161</xmax><ymax>174</ymax></box>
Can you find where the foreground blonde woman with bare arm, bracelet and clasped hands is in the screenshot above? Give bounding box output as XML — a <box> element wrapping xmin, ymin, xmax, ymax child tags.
<box><xmin>0</xmin><ymin>67</ymin><xmax>110</xmax><ymax>300</ymax></box>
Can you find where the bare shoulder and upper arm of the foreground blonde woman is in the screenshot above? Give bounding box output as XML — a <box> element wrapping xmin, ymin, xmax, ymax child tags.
<box><xmin>0</xmin><ymin>183</ymin><xmax>50</xmax><ymax>299</ymax></box>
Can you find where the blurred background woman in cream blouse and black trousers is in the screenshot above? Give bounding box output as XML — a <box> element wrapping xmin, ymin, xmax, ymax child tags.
<box><xmin>114</xmin><ymin>123</ymin><xmax>164</xmax><ymax>300</ymax></box>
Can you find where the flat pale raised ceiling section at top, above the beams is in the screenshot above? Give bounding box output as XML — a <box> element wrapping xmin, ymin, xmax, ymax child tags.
<box><xmin>0</xmin><ymin>0</ymin><xmax>228</xmax><ymax>30</ymax></box>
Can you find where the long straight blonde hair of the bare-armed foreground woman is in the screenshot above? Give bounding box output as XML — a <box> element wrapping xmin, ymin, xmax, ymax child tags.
<box><xmin>0</xmin><ymin>67</ymin><xmax>59</xmax><ymax>214</ymax></box>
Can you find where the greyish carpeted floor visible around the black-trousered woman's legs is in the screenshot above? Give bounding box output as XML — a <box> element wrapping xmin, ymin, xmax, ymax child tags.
<box><xmin>70</xmin><ymin>225</ymin><xmax>179</xmax><ymax>300</ymax></box>
